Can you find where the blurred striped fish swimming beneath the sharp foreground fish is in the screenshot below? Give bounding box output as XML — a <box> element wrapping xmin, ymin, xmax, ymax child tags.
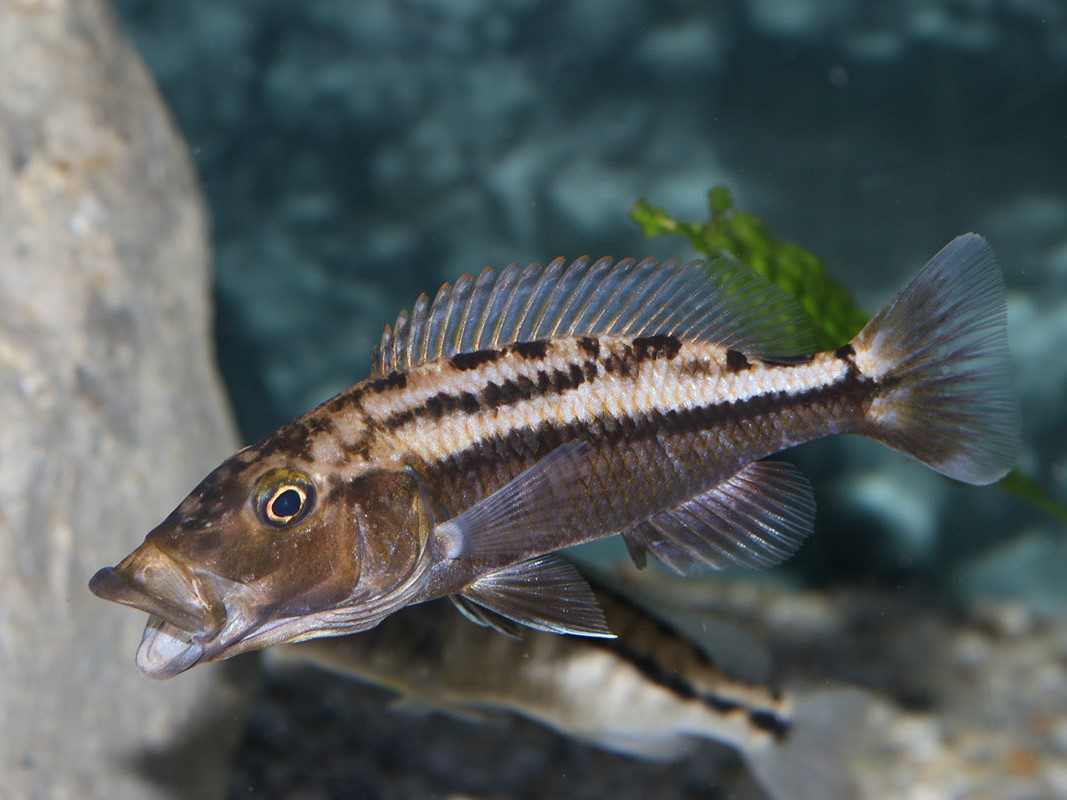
<box><xmin>268</xmin><ymin>571</ymin><xmax>870</xmax><ymax>800</ymax></box>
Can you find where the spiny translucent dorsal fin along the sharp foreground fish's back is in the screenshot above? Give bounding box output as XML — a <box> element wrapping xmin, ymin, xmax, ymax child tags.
<box><xmin>373</xmin><ymin>256</ymin><xmax>814</xmax><ymax>378</ymax></box>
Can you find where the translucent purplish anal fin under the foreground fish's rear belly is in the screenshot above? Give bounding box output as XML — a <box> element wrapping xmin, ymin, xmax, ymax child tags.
<box><xmin>623</xmin><ymin>461</ymin><xmax>815</xmax><ymax>574</ymax></box>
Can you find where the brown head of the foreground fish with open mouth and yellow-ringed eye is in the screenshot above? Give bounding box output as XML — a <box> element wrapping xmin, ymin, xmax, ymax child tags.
<box><xmin>90</xmin><ymin>428</ymin><xmax>433</xmax><ymax>679</ymax></box>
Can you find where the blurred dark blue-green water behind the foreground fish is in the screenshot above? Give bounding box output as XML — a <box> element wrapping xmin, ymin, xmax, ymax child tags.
<box><xmin>116</xmin><ymin>0</ymin><xmax>1067</xmax><ymax>797</ymax></box>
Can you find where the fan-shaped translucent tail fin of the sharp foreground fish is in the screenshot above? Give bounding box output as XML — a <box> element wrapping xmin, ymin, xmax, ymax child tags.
<box><xmin>851</xmin><ymin>234</ymin><xmax>1020</xmax><ymax>484</ymax></box>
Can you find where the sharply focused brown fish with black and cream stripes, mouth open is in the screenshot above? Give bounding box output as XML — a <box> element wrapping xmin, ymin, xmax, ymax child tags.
<box><xmin>90</xmin><ymin>234</ymin><xmax>1020</xmax><ymax>679</ymax></box>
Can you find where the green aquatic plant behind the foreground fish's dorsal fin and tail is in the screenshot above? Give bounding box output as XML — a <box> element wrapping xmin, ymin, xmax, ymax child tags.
<box><xmin>630</xmin><ymin>186</ymin><xmax>1067</xmax><ymax>523</ymax></box>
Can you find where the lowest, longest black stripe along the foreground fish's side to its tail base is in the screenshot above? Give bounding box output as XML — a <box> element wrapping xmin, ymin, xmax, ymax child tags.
<box><xmin>448</xmin><ymin>368</ymin><xmax>876</xmax><ymax>480</ymax></box>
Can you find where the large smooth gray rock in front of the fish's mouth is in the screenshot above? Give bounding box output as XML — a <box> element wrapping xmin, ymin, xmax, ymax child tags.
<box><xmin>0</xmin><ymin>0</ymin><xmax>245</xmax><ymax>799</ymax></box>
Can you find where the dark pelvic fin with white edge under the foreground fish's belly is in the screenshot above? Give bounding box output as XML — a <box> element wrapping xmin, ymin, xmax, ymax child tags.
<box><xmin>453</xmin><ymin>556</ymin><xmax>615</xmax><ymax>639</ymax></box>
